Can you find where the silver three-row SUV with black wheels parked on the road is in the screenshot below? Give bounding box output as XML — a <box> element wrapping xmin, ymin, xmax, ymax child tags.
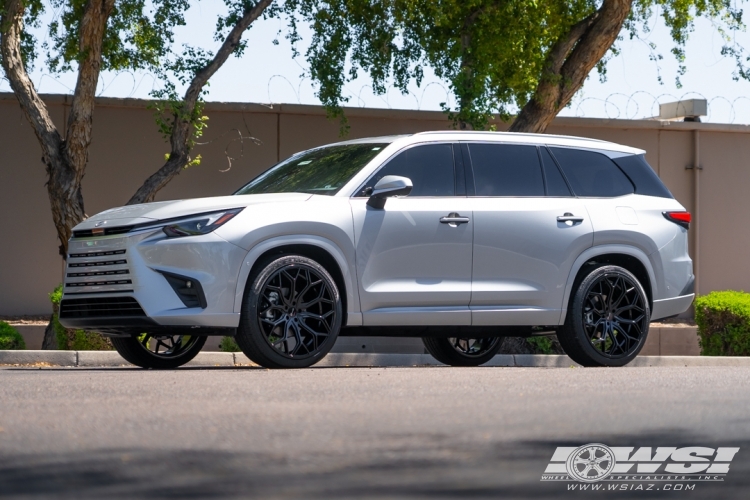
<box><xmin>60</xmin><ymin>132</ymin><xmax>694</xmax><ymax>368</ymax></box>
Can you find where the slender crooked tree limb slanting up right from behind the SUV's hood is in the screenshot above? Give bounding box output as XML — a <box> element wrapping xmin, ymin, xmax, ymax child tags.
<box><xmin>128</xmin><ymin>0</ymin><xmax>273</xmax><ymax>205</ymax></box>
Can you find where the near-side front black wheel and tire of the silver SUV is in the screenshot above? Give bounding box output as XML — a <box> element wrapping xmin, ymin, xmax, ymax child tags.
<box><xmin>236</xmin><ymin>255</ymin><xmax>343</xmax><ymax>368</ymax></box>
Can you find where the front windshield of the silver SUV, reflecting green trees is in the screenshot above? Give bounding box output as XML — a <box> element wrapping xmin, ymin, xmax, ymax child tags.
<box><xmin>234</xmin><ymin>143</ymin><xmax>388</xmax><ymax>196</ymax></box>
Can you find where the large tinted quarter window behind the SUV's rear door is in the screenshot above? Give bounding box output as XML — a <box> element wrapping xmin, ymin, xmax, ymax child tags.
<box><xmin>550</xmin><ymin>148</ymin><xmax>633</xmax><ymax>198</ymax></box>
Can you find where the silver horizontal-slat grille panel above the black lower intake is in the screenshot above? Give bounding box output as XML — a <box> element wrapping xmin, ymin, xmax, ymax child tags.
<box><xmin>65</xmin><ymin>245</ymin><xmax>134</xmax><ymax>294</ymax></box>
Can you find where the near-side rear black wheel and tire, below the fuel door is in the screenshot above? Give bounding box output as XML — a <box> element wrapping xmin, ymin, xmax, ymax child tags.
<box><xmin>557</xmin><ymin>265</ymin><xmax>651</xmax><ymax>366</ymax></box>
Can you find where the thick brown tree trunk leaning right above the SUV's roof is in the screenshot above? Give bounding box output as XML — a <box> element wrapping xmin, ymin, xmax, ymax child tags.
<box><xmin>510</xmin><ymin>0</ymin><xmax>632</xmax><ymax>133</ymax></box>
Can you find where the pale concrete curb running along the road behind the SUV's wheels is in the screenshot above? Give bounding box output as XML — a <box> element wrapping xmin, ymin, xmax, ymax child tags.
<box><xmin>0</xmin><ymin>351</ymin><xmax>750</xmax><ymax>368</ymax></box>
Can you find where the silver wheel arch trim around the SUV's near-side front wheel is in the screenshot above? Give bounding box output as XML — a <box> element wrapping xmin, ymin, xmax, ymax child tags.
<box><xmin>234</xmin><ymin>234</ymin><xmax>362</xmax><ymax>326</ymax></box>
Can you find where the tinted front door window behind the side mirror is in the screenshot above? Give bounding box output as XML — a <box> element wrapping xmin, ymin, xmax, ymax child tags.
<box><xmin>359</xmin><ymin>144</ymin><xmax>456</xmax><ymax>196</ymax></box>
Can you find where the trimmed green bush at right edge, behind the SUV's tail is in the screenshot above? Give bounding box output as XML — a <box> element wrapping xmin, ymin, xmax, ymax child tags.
<box><xmin>695</xmin><ymin>290</ymin><xmax>750</xmax><ymax>356</ymax></box>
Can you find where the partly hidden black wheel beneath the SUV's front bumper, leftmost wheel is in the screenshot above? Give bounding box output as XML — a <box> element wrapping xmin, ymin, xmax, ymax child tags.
<box><xmin>112</xmin><ymin>334</ymin><xmax>206</xmax><ymax>370</ymax></box>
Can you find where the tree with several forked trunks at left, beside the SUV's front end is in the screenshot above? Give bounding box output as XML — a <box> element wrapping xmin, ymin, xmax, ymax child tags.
<box><xmin>0</xmin><ymin>0</ymin><xmax>273</xmax><ymax>347</ymax></box>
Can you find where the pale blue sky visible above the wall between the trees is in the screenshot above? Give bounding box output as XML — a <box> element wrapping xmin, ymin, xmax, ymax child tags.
<box><xmin>0</xmin><ymin>0</ymin><xmax>750</xmax><ymax>123</ymax></box>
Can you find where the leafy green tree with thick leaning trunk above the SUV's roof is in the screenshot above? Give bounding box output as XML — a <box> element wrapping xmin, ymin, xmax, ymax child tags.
<box><xmin>286</xmin><ymin>0</ymin><xmax>750</xmax><ymax>132</ymax></box>
